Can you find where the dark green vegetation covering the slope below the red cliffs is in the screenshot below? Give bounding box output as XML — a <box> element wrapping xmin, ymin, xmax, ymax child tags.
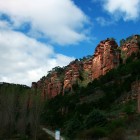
<box><xmin>41</xmin><ymin>53</ymin><xmax>140</xmax><ymax>140</ymax></box>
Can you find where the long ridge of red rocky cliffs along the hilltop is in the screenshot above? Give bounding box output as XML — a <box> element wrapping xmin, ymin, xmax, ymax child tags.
<box><xmin>32</xmin><ymin>35</ymin><xmax>140</xmax><ymax>99</ymax></box>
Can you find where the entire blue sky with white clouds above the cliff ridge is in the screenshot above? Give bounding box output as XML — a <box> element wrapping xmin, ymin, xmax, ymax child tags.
<box><xmin>0</xmin><ymin>0</ymin><xmax>140</xmax><ymax>85</ymax></box>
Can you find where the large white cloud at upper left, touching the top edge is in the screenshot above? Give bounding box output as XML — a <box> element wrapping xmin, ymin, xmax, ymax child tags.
<box><xmin>0</xmin><ymin>0</ymin><xmax>88</xmax><ymax>45</ymax></box>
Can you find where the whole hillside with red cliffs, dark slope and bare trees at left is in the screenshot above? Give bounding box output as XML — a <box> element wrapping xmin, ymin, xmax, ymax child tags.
<box><xmin>0</xmin><ymin>35</ymin><xmax>140</xmax><ymax>140</ymax></box>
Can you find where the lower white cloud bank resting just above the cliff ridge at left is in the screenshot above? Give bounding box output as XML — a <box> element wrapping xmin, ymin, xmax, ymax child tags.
<box><xmin>0</xmin><ymin>26</ymin><xmax>74</xmax><ymax>85</ymax></box>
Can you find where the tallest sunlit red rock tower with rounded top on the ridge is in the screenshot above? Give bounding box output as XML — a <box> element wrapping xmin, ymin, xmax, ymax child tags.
<box><xmin>92</xmin><ymin>39</ymin><xmax>120</xmax><ymax>79</ymax></box>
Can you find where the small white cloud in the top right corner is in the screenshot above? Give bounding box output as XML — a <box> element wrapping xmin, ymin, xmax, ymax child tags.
<box><xmin>102</xmin><ymin>0</ymin><xmax>140</xmax><ymax>21</ymax></box>
